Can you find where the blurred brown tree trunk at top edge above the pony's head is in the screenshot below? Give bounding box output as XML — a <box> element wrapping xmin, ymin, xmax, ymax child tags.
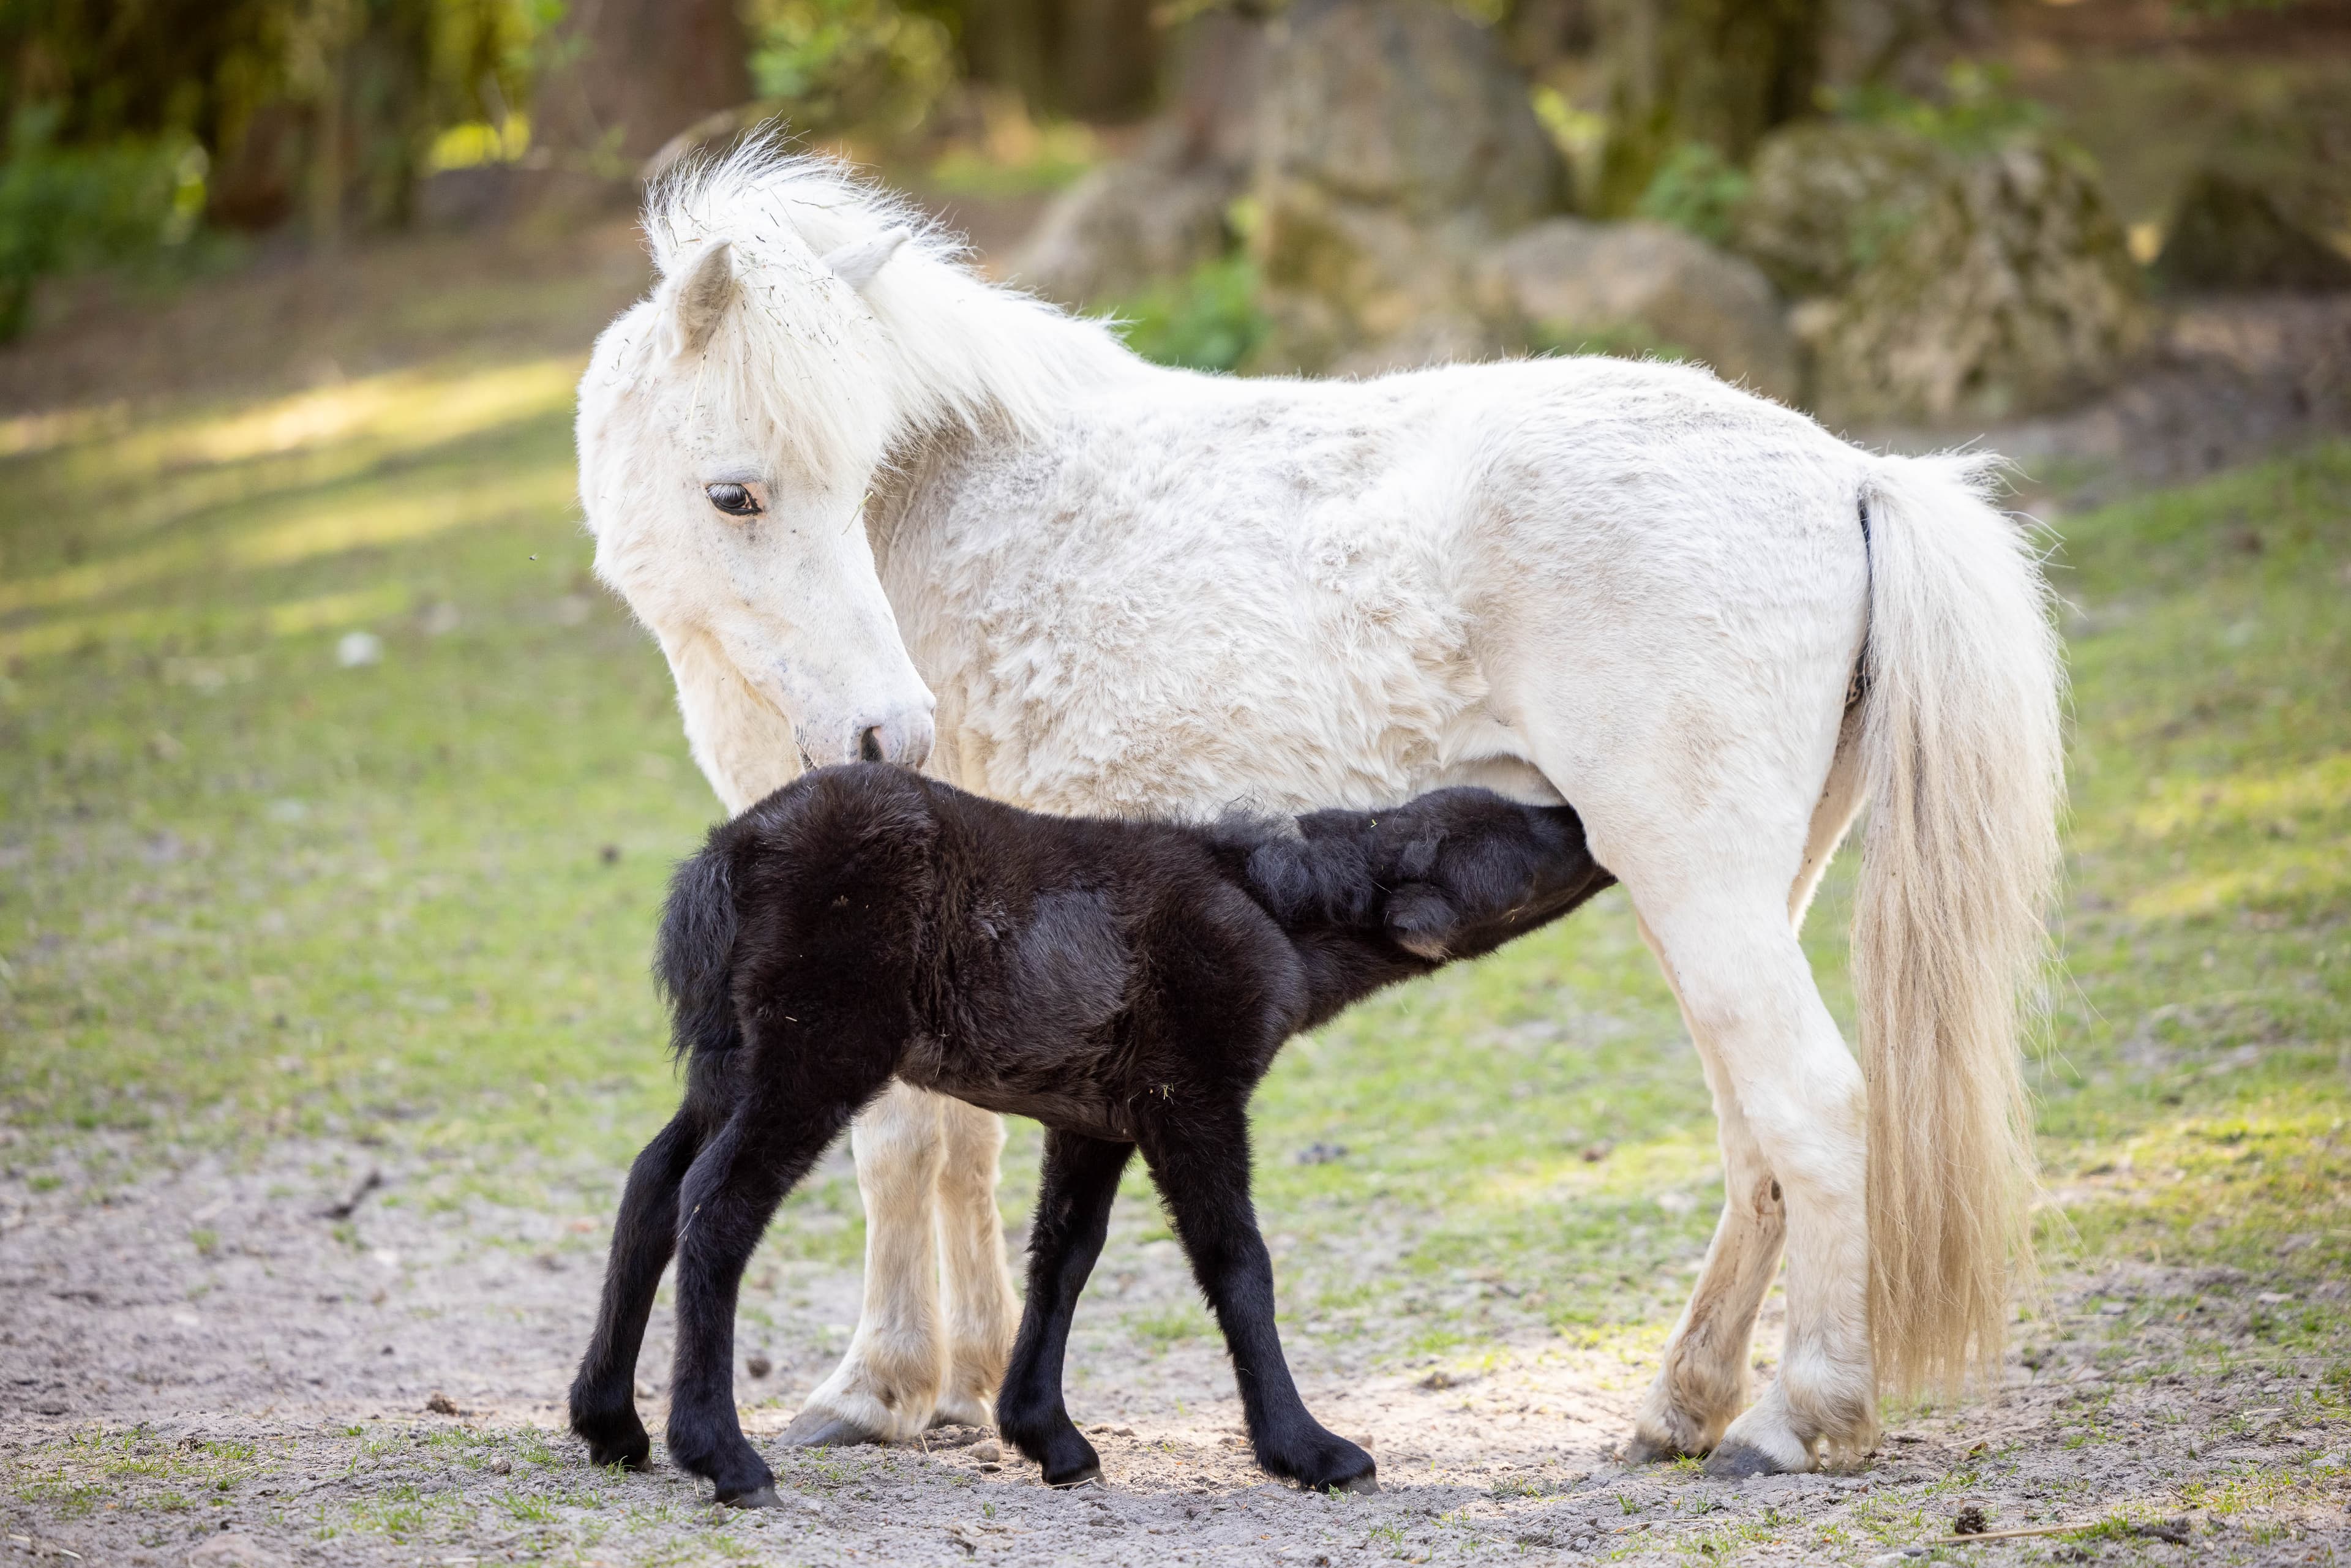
<box><xmin>531</xmin><ymin>0</ymin><xmax>752</xmax><ymax>179</ymax></box>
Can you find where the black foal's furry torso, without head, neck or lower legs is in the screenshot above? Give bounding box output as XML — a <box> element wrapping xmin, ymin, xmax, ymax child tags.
<box><xmin>713</xmin><ymin>764</ymin><xmax>1305</xmax><ymax>1138</ymax></box>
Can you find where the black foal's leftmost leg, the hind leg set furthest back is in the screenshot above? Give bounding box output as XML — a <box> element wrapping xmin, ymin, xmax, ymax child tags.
<box><xmin>571</xmin><ymin>1109</ymin><xmax>700</xmax><ymax>1469</ymax></box>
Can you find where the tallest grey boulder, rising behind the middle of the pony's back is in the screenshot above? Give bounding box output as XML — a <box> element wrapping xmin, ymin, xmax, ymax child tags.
<box><xmin>1251</xmin><ymin>0</ymin><xmax>1565</xmax><ymax>373</ymax></box>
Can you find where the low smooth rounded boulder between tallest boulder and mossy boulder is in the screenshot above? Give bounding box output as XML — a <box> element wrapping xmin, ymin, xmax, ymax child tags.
<box><xmin>1488</xmin><ymin>219</ymin><xmax>1801</xmax><ymax>402</ymax></box>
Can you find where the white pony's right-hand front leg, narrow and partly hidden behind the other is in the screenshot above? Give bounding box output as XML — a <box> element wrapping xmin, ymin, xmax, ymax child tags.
<box><xmin>933</xmin><ymin>1100</ymin><xmax>1021</xmax><ymax>1427</ymax></box>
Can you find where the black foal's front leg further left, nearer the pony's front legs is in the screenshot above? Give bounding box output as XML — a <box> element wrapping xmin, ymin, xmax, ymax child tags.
<box><xmin>997</xmin><ymin>1128</ymin><xmax>1136</xmax><ymax>1486</ymax></box>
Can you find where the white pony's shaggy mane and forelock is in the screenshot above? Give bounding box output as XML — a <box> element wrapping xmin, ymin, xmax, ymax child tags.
<box><xmin>644</xmin><ymin>134</ymin><xmax>1142</xmax><ymax>500</ymax></box>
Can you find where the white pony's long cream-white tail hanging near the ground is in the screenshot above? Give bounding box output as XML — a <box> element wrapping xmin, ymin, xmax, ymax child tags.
<box><xmin>1853</xmin><ymin>456</ymin><xmax>2064</xmax><ymax>1394</ymax></box>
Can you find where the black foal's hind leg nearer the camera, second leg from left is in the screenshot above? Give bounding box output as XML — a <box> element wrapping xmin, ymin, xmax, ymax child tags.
<box><xmin>670</xmin><ymin>1084</ymin><xmax>874</xmax><ymax>1507</ymax></box>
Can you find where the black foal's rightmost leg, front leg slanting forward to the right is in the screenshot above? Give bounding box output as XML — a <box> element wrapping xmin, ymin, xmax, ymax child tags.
<box><xmin>1142</xmin><ymin>1105</ymin><xmax>1380</xmax><ymax>1493</ymax></box>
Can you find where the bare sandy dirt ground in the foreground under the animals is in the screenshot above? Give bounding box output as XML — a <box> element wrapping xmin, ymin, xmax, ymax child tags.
<box><xmin>0</xmin><ymin>1145</ymin><xmax>2351</xmax><ymax>1566</ymax></box>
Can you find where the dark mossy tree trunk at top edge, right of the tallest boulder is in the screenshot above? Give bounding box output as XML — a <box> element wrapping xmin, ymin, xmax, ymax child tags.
<box><xmin>1592</xmin><ymin>0</ymin><xmax>1831</xmax><ymax>216</ymax></box>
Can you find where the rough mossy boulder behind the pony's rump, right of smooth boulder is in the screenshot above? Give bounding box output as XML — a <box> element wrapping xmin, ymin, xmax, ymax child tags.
<box><xmin>1735</xmin><ymin>124</ymin><xmax>2151</xmax><ymax>423</ymax></box>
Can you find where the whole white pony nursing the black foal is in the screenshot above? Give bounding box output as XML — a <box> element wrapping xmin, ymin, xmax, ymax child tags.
<box><xmin>579</xmin><ymin>146</ymin><xmax>2062</xmax><ymax>1474</ymax></box>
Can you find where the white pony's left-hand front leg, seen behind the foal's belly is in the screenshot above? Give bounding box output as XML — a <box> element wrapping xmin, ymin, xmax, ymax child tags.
<box><xmin>783</xmin><ymin>1081</ymin><xmax>948</xmax><ymax>1448</ymax></box>
